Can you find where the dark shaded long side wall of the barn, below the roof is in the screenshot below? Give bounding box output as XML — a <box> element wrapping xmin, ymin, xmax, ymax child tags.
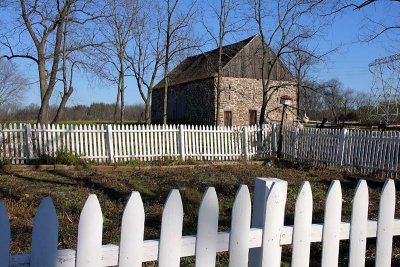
<box><xmin>151</xmin><ymin>78</ymin><xmax>215</xmax><ymax>125</ymax></box>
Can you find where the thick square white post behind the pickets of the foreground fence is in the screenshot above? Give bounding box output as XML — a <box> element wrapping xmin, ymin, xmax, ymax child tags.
<box><xmin>249</xmin><ymin>177</ymin><xmax>288</xmax><ymax>267</ymax></box>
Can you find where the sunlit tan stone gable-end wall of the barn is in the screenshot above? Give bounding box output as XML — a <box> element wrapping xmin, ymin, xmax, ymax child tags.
<box><xmin>218</xmin><ymin>77</ymin><xmax>297</xmax><ymax>126</ymax></box>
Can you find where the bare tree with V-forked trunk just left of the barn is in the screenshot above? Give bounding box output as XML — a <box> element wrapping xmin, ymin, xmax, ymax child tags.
<box><xmin>127</xmin><ymin>4</ymin><xmax>164</xmax><ymax>124</ymax></box>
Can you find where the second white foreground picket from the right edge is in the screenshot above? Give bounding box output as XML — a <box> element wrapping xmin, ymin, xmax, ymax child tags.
<box><xmin>349</xmin><ymin>180</ymin><xmax>368</xmax><ymax>267</ymax></box>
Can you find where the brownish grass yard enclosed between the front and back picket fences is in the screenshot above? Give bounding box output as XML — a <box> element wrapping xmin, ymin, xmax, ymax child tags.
<box><xmin>0</xmin><ymin>163</ymin><xmax>400</xmax><ymax>266</ymax></box>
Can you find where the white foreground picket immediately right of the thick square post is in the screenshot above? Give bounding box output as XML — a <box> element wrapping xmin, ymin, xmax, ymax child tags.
<box><xmin>292</xmin><ymin>182</ymin><xmax>313</xmax><ymax>267</ymax></box>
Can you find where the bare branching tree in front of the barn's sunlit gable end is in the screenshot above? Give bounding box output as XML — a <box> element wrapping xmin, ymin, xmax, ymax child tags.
<box><xmin>250</xmin><ymin>0</ymin><xmax>322</xmax><ymax>125</ymax></box>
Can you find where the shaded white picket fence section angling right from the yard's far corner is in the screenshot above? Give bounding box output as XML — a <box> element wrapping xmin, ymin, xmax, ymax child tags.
<box><xmin>283</xmin><ymin>127</ymin><xmax>400</xmax><ymax>176</ymax></box>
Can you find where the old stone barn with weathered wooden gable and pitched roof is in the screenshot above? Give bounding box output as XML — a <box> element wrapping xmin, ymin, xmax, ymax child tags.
<box><xmin>151</xmin><ymin>35</ymin><xmax>297</xmax><ymax>126</ymax></box>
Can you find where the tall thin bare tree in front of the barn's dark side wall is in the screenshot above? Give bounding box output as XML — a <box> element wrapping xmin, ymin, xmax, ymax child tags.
<box><xmin>162</xmin><ymin>0</ymin><xmax>200</xmax><ymax>124</ymax></box>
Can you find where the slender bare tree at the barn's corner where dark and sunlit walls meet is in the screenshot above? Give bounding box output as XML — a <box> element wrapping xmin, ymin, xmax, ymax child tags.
<box><xmin>203</xmin><ymin>0</ymin><xmax>243</xmax><ymax>126</ymax></box>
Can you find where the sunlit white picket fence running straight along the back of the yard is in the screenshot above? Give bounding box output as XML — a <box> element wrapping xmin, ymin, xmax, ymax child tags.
<box><xmin>0</xmin><ymin>123</ymin><xmax>274</xmax><ymax>164</ymax></box>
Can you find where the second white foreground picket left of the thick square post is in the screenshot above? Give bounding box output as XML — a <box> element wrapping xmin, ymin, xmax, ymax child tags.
<box><xmin>195</xmin><ymin>187</ymin><xmax>219</xmax><ymax>267</ymax></box>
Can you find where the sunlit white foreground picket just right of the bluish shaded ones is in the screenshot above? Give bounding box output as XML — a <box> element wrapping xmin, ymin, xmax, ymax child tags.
<box><xmin>76</xmin><ymin>195</ymin><xmax>103</xmax><ymax>267</ymax></box>
